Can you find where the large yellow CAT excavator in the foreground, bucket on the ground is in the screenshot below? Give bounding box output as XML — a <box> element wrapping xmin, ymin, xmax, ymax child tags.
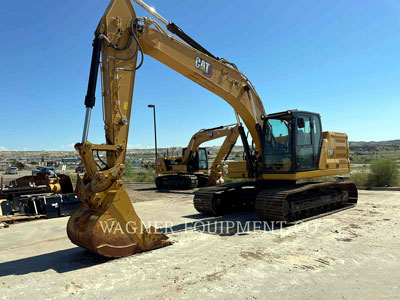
<box><xmin>67</xmin><ymin>0</ymin><xmax>357</xmax><ymax>257</ymax></box>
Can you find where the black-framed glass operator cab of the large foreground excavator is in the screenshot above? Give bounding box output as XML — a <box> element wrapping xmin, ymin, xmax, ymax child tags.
<box><xmin>263</xmin><ymin>110</ymin><xmax>322</xmax><ymax>174</ymax></box>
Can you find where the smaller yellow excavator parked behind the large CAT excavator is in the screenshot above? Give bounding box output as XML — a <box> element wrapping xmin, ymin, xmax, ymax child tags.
<box><xmin>155</xmin><ymin>124</ymin><xmax>239</xmax><ymax>189</ymax></box>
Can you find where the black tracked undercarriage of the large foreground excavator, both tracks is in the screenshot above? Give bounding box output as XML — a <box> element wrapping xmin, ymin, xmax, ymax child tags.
<box><xmin>193</xmin><ymin>180</ymin><xmax>358</xmax><ymax>223</ymax></box>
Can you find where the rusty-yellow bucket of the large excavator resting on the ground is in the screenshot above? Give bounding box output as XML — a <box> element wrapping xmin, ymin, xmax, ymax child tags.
<box><xmin>67</xmin><ymin>189</ymin><xmax>171</xmax><ymax>257</ymax></box>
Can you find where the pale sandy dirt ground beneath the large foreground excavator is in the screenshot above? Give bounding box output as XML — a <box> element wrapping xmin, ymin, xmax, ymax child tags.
<box><xmin>0</xmin><ymin>184</ymin><xmax>400</xmax><ymax>300</ymax></box>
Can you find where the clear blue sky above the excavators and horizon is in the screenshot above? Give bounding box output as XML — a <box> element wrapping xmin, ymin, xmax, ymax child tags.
<box><xmin>0</xmin><ymin>0</ymin><xmax>400</xmax><ymax>150</ymax></box>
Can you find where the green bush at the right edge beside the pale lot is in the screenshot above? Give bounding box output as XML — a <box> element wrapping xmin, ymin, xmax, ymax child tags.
<box><xmin>367</xmin><ymin>159</ymin><xmax>399</xmax><ymax>187</ymax></box>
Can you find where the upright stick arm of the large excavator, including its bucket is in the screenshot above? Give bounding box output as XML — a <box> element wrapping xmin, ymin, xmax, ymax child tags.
<box><xmin>67</xmin><ymin>0</ymin><xmax>170</xmax><ymax>257</ymax></box>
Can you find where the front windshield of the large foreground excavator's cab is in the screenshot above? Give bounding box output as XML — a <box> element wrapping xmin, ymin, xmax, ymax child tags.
<box><xmin>263</xmin><ymin>118</ymin><xmax>292</xmax><ymax>172</ymax></box>
